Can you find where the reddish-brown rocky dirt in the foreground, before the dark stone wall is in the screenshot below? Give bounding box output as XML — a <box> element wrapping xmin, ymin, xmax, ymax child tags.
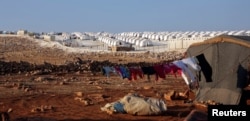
<box><xmin>0</xmin><ymin>74</ymin><xmax>192</xmax><ymax>121</ymax></box>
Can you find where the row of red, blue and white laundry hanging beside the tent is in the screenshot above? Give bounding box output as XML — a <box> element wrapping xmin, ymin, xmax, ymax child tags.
<box><xmin>102</xmin><ymin>57</ymin><xmax>201</xmax><ymax>89</ymax></box>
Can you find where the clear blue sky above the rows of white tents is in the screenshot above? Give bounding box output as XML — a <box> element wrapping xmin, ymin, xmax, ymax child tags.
<box><xmin>0</xmin><ymin>0</ymin><xmax>250</xmax><ymax>33</ymax></box>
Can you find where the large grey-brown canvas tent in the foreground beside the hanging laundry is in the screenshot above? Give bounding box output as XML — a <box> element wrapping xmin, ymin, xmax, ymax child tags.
<box><xmin>187</xmin><ymin>35</ymin><xmax>250</xmax><ymax>105</ymax></box>
